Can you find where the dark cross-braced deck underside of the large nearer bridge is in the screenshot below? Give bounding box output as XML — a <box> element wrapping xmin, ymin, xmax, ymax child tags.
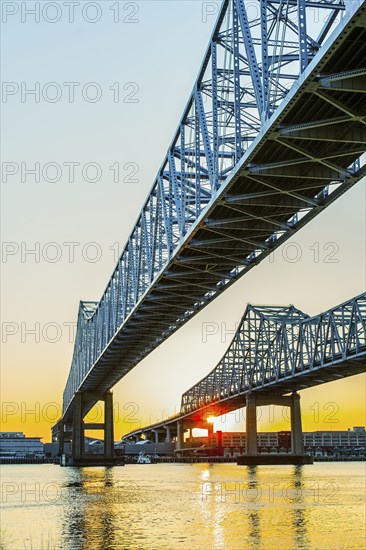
<box><xmin>66</xmin><ymin>6</ymin><xmax>366</xmax><ymax>424</ymax></box>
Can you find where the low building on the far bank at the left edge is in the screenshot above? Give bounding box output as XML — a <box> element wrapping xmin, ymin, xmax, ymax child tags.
<box><xmin>0</xmin><ymin>432</ymin><xmax>44</xmax><ymax>459</ymax></box>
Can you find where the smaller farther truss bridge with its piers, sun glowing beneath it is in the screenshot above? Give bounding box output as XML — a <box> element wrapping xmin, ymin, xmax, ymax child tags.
<box><xmin>125</xmin><ymin>293</ymin><xmax>366</xmax><ymax>462</ymax></box>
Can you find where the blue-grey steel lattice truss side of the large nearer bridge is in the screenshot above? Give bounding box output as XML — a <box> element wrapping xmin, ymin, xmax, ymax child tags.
<box><xmin>64</xmin><ymin>0</ymin><xmax>358</xmax><ymax>410</ymax></box>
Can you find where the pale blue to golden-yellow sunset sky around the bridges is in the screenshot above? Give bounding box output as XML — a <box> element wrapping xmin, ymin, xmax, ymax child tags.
<box><xmin>1</xmin><ymin>0</ymin><xmax>366</xmax><ymax>441</ymax></box>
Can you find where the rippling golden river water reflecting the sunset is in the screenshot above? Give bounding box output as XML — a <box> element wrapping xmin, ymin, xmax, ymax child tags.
<box><xmin>0</xmin><ymin>462</ymin><xmax>365</xmax><ymax>550</ymax></box>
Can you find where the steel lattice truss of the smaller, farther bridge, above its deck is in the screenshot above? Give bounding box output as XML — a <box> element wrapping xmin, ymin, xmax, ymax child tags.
<box><xmin>181</xmin><ymin>293</ymin><xmax>366</xmax><ymax>414</ymax></box>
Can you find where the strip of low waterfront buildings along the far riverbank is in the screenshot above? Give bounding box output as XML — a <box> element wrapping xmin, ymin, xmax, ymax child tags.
<box><xmin>0</xmin><ymin>426</ymin><xmax>366</xmax><ymax>462</ymax></box>
